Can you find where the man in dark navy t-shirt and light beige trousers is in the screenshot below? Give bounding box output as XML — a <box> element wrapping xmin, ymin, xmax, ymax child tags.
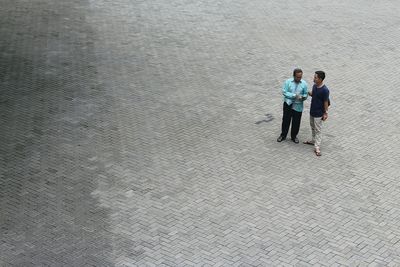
<box><xmin>304</xmin><ymin>71</ymin><xmax>329</xmax><ymax>156</ymax></box>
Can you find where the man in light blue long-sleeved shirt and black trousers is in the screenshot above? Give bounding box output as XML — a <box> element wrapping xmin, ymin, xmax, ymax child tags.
<box><xmin>277</xmin><ymin>68</ymin><xmax>308</xmax><ymax>144</ymax></box>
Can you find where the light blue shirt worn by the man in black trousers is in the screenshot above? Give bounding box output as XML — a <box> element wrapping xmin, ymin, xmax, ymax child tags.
<box><xmin>282</xmin><ymin>78</ymin><xmax>308</xmax><ymax>112</ymax></box>
